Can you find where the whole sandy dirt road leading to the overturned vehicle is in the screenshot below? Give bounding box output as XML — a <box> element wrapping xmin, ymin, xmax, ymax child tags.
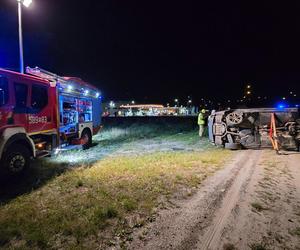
<box><xmin>129</xmin><ymin>150</ymin><xmax>300</xmax><ymax>250</ymax></box>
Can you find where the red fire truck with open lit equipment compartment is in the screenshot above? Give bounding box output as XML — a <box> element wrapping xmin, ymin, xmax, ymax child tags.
<box><xmin>0</xmin><ymin>67</ymin><xmax>101</xmax><ymax>175</ymax></box>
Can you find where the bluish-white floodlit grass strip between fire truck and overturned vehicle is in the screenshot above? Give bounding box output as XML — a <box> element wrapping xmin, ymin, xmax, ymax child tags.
<box><xmin>48</xmin><ymin>123</ymin><xmax>214</xmax><ymax>166</ymax></box>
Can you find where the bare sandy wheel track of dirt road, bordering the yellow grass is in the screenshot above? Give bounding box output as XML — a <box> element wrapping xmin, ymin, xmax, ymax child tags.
<box><xmin>129</xmin><ymin>150</ymin><xmax>261</xmax><ymax>249</ymax></box>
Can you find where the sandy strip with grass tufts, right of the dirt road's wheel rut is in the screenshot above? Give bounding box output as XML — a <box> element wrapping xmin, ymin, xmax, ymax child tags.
<box><xmin>218</xmin><ymin>150</ymin><xmax>300</xmax><ymax>250</ymax></box>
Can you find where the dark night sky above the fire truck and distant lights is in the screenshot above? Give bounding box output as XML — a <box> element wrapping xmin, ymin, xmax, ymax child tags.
<box><xmin>0</xmin><ymin>0</ymin><xmax>300</xmax><ymax>104</ymax></box>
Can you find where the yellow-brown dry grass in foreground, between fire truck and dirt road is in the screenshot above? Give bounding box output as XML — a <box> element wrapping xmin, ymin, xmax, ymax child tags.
<box><xmin>0</xmin><ymin>150</ymin><xmax>232</xmax><ymax>249</ymax></box>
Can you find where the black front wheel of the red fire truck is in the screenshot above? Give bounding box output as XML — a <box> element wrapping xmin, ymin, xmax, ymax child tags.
<box><xmin>2</xmin><ymin>144</ymin><xmax>30</xmax><ymax>175</ymax></box>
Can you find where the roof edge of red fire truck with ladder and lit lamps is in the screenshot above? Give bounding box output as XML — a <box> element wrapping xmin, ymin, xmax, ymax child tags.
<box><xmin>26</xmin><ymin>67</ymin><xmax>100</xmax><ymax>98</ymax></box>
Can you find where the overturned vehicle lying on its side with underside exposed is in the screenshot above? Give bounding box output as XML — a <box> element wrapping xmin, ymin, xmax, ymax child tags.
<box><xmin>208</xmin><ymin>108</ymin><xmax>300</xmax><ymax>150</ymax></box>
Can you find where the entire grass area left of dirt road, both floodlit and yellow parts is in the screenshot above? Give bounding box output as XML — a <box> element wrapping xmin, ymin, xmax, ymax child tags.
<box><xmin>0</xmin><ymin>121</ymin><xmax>233</xmax><ymax>249</ymax></box>
